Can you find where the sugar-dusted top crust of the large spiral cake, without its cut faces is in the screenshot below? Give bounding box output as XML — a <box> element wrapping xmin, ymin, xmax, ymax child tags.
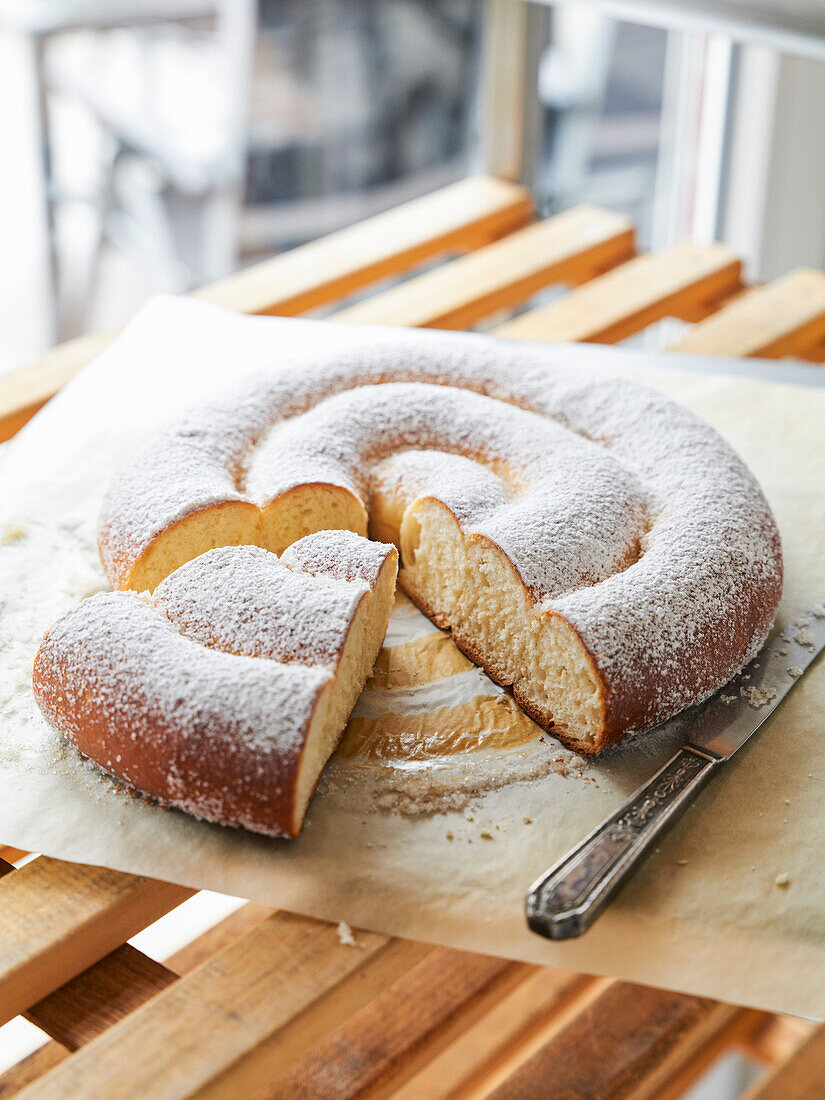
<box><xmin>102</xmin><ymin>331</ymin><xmax>782</xmax><ymax>728</ymax></box>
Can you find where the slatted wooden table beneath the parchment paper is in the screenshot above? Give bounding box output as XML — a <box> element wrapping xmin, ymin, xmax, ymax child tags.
<box><xmin>0</xmin><ymin>177</ymin><xmax>825</xmax><ymax>1100</ymax></box>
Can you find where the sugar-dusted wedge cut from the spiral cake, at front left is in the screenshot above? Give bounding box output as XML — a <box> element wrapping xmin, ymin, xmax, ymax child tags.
<box><xmin>33</xmin><ymin>530</ymin><xmax>397</xmax><ymax>837</ymax></box>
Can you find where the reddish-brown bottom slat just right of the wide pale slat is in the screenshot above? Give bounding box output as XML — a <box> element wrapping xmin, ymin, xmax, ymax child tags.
<box><xmin>256</xmin><ymin>948</ymin><xmax>535</xmax><ymax>1100</ymax></box>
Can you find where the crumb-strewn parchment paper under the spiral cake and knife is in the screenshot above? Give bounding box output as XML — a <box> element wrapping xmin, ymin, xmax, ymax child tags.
<box><xmin>0</xmin><ymin>299</ymin><xmax>825</xmax><ymax>1018</ymax></box>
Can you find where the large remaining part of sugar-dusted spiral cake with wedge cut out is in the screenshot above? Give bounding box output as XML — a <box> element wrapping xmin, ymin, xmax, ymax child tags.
<box><xmin>93</xmin><ymin>333</ymin><xmax>782</xmax><ymax>754</ymax></box>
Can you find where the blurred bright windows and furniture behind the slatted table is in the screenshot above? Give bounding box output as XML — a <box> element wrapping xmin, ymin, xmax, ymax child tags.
<box><xmin>0</xmin><ymin>0</ymin><xmax>825</xmax><ymax>372</ymax></box>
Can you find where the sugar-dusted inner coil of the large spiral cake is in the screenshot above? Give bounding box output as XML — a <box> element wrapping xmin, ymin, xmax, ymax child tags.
<box><xmin>246</xmin><ymin>383</ymin><xmax>648</xmax><ymax>600</ymax></box>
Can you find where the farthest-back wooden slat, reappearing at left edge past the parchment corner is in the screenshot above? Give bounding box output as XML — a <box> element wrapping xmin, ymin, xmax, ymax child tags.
<box><xmin>0</xmin><ymin>176</ymin><xmax>532</xmax><ymax>440</ymax></box>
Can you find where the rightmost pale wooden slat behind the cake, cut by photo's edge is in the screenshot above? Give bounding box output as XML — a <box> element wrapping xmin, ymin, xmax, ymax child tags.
<box><xmin>671</xmin><ymin>267</ymin><xmax>825</xmax><ymax>359</ymax></box>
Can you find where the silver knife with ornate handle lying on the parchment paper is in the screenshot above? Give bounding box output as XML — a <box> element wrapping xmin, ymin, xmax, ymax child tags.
<box><xmin>526</xmin><ymin>602</ymin><xmax>825</xmax><ymax>939</ymax></box>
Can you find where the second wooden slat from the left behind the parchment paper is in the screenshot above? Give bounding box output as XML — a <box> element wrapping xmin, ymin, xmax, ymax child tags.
<box><xmin>336</xmin><ymin>206</ymin><xmax>634</xmax><ymax>329</ymax></box>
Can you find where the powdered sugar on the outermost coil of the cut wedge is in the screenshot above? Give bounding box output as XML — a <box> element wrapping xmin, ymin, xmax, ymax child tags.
<box><xmin>35</xmin><ymin>592</ymin><xmax>331</xmax><ymax>761</ymax></box>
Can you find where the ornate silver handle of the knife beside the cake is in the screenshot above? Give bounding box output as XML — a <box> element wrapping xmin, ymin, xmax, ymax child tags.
<box><xmin>527</xmin><ymin>745</ymin><xmax>723</xmax><ymax>939</ymax></box>
